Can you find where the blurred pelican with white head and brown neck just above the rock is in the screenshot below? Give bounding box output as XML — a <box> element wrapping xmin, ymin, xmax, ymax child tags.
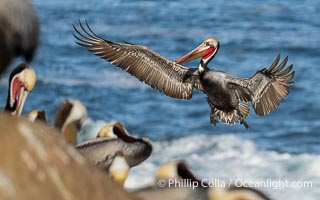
<box><xmin>53</xmin><ymin>100</ymin><xmax>87</xmax><ymax>145</ymax></box>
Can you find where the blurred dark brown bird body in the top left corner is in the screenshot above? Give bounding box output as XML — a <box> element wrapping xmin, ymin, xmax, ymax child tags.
<box><xmin>0</xmin><ymin>0</ymin><xmax>39</xmax><ymax>74</ymax></box>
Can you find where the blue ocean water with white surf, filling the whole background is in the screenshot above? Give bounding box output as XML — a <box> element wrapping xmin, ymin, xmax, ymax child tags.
<box><xmin>0</xmin><ymin>0</ymin><xmax>320</xmax><ymax>199</ymax></box>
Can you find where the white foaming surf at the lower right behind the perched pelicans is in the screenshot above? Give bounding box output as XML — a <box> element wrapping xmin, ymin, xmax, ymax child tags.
<box><xmin>125</xmin><ymin>134</ymin><xmax>320</xmax><ymax>199</ymax></box>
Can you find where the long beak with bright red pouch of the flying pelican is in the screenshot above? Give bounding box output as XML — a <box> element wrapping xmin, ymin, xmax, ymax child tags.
<box><xmin>174</xmin><ymin>42</ymin><xmax>217</xmax><ymax>64</ymax></box>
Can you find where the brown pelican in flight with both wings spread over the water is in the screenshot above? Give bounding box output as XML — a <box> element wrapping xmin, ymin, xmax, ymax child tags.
<box><xmin>74</xmin><ymin>22</ymin><xmax>294</xmax><ymax>128</ymax></box>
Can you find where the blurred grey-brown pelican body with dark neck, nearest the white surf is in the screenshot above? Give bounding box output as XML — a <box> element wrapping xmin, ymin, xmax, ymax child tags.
<box><xmin>76</xmin><ymin>123</ymin><xmax>152</xmax><ymax>171</ymax></box>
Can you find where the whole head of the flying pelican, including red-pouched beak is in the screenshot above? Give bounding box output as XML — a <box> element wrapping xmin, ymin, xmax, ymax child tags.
<box><xmin>175</xmin><ymin>38</ymin><xmax>219</xmax><ymax>71</ymax></box>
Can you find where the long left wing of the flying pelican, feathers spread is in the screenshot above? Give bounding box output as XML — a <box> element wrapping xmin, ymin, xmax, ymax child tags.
<box><xmin>73</xmin><ymin>22</ymin><xmax>198</xmax><ymax>99</ymax></box>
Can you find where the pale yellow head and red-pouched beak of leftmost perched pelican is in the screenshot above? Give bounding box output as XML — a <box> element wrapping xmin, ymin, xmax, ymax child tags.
<box><xmin>10</xmin><ymin>68</ymin><xmax>36</xmax><ymax>117</ymax></box>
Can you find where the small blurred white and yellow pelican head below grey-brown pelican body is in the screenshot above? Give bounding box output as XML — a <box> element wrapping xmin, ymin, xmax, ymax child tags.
<box><xmin>109</xmin><ymin>151</ymin><xmax>130</xmax><ymax>186</ymax></box>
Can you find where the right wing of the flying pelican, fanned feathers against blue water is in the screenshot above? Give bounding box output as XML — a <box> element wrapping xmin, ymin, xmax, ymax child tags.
<box><xmin>229</xmin><ymin>55</ymin><xmax>295</xmax><ymax>116</ymax></box>
